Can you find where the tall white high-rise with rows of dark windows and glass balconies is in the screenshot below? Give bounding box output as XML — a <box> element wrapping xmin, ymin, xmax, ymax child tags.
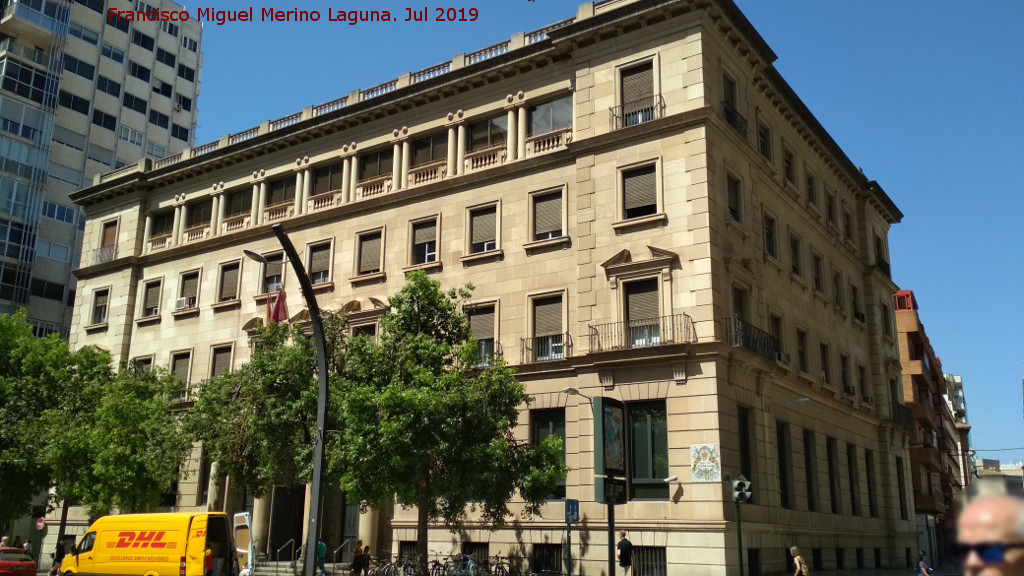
<box><xmin>0</xmin><ymin>0</ymin><xmax>202</xmax><ymax>336</ymax></box>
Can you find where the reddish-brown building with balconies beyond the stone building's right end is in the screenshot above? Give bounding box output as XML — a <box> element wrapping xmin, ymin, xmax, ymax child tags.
<box><xmin>895</xmin><ymin>290</ymin><xmax>965</xmax><ymax>559</ymax></box>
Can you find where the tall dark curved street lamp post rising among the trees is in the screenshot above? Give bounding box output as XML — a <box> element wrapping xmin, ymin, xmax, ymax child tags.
<box><xmin>246</xmin><ymin>223</ymin><xmax>328</xmax><ymax>576</ymax></box>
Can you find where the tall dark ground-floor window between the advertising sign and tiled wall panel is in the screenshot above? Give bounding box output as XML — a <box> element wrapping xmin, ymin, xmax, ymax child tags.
<box><xmin>627</xmin><ymin>400</ymin><xmax>669</xmax><ymax>500</ymax></box>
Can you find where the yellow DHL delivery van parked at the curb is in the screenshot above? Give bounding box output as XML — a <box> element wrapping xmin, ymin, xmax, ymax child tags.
<box><xmin>60</xmin><ymin>512</ymin><xmax>249</xmax><ymax>576</ymax></box>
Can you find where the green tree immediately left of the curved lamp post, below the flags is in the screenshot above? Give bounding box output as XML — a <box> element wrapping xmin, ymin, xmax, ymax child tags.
<box><xmin>187</xmin><ymin>312</ymin><xmax>345</xmax><ymax>496</ymax></box>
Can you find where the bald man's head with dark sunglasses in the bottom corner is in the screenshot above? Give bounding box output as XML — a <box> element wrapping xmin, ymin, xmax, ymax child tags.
<box><xmin>956</xmin><ymin>496</ymin><xmax>1024</xmax><ymax>576</ymax></box>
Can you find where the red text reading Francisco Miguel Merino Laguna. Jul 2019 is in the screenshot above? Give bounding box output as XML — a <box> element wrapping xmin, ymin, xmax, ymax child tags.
<box><xmin>106</xmin><ymin>6</ymin><xmax>479</xmax><ymax>26</ymax></box>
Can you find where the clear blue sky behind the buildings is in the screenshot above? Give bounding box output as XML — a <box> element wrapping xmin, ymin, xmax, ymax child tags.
<box><xmin>187</xmin><ymin>0</ymin><xmax>1024</xmax><ymax>461</ymax></box>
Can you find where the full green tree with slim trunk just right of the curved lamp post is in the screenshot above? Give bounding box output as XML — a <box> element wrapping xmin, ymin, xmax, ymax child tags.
<box><xmin>336</xmin><ymin>272</ymin><xmax>565</xmax><ymax>574</ymax></box>
